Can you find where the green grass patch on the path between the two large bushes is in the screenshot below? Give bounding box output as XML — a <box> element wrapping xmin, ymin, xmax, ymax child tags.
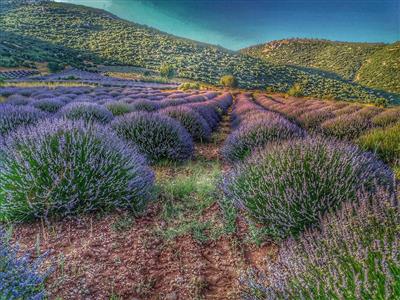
<box><xmin>156</xmin><ymin>161</ymin><xmax>223</xmax><ymax>243</ymax></box>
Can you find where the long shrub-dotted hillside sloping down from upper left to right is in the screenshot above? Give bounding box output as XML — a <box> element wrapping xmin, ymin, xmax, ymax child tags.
<box><xmin>0</xmin><ymin>0</ymin><xmax>391</xmax><ymax>103</ymax></box>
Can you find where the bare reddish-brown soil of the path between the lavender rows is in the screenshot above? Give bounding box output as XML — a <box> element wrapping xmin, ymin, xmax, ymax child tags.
<box><xmin>14</xmin><ymin>96</ymin><xmax>277</xmax><ymax>300</ymax></box>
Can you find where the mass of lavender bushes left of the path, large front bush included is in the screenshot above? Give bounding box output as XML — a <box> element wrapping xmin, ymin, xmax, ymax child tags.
<box><xmin>0</xmin><ymin>89</ymin><xmax>232</xmax><ymax>221</ymax></box>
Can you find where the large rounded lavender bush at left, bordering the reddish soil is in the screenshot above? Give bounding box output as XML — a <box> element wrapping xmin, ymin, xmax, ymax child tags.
<box><xmin>0</xmin><ymin>119</ymin><xmax>153</xmax><ymax>221</ymax></box>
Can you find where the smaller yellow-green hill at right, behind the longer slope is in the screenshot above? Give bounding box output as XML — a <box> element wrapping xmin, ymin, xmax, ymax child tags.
<box><xmin>241</xmin><ymin>39</ymin><xmax>400</xmax><ymax>93</ymax></box>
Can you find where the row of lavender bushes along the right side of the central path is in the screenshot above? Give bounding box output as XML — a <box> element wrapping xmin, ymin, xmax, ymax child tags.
<box><xmin>222</xmin><ymin>94</ymin><xmax>400</xmax><ymax>299</ymax></box>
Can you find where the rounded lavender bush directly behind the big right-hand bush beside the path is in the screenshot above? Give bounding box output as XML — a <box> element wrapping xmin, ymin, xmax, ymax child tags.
<box><xmin>221</xmin><ymin>113</ymin><xmax>304</xmax><ymax>163</ymax></box>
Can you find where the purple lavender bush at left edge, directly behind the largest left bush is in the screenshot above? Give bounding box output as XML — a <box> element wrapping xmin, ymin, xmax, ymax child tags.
<box><xmin>0</xmin><ymin>104</ymin><xmax>46</xmax><ymax>136</ymax></box>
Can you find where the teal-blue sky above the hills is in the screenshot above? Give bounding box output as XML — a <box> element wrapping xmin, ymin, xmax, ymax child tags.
<box><xmin>57</xmin><ymin>0</ymin><xmax>400</xmax><ymax>50</ymax></box>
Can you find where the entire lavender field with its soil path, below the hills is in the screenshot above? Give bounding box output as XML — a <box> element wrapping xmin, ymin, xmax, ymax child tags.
<box><xmin>0</xmin><ymin>72</ymin><xmax>400</xmax><ymax>299</ymax></box>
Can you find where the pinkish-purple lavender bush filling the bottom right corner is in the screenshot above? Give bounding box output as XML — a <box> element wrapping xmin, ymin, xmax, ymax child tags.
<box><xmin>244</xmin><ymin>192</ymin><xmax>400</xmax><ymax>299</ymax></box>
